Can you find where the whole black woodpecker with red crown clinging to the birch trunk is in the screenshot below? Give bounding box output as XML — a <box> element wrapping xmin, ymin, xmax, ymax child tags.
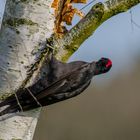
<box><xmin>0</xmin><ymin>57</ymin><xmax>112</xmax><ymax>116</ymax></box>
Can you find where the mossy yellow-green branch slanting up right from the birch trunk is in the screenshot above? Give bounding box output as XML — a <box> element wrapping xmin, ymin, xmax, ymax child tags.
<box><xmin>55</xmin><ymin>0</ymin><xmax>140</xmax><ymax>61</ymax></box>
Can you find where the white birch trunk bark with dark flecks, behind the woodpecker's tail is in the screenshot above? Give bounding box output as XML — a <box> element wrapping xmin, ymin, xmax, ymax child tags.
<box><xmin>0</xmin><ymin>0</ymin><xmax>54</xmax><ymax>140</ymax></box>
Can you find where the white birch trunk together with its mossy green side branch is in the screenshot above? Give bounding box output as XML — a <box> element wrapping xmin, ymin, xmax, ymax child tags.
<box><xmin>0</xmin><ymin>0</ymin><xmax>140</xmax><ymax>140</ymax></box>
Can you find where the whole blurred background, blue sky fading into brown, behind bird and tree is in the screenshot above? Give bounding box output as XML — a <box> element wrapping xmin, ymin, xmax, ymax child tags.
<box><xmin>0</xmin><ymin>0</ymin><xmax>140</xmax><ymax>140</ymax></box>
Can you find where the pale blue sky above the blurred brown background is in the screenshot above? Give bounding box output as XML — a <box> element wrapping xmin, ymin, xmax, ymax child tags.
<box><xmin>0</xmin><ymin>0</ymin><xmax>140</xmax><ymax>83</ymax></box>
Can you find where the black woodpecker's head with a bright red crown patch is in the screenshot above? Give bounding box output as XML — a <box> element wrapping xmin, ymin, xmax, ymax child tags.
<box><xmin>95</xmin><ymin>58</ymin><xmax>112</xmax><ymax>75</ymax></box>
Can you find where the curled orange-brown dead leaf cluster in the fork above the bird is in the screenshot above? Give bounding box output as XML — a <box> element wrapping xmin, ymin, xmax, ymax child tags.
<box><xmin>51</xmin><ymin>0</ymin><xmax>87</xmax><ymax>34</ymax></box>
